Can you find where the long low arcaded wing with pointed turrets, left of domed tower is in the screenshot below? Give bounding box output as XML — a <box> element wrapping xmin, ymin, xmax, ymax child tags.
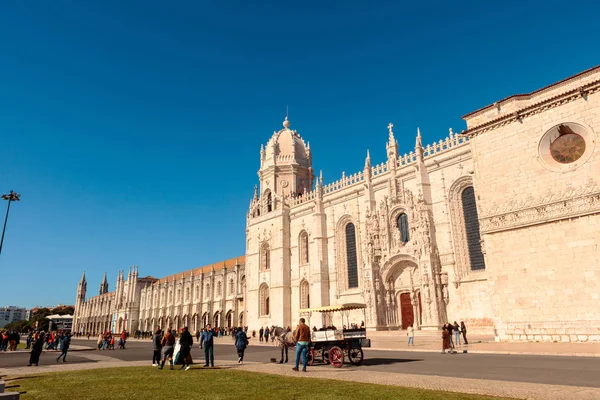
<box><xmin>73</xmin><ymin>257</ymin><xmax>246</xmax><ymax>333</ymax></box>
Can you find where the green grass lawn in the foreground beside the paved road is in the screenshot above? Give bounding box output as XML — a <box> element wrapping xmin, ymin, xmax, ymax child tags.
<box><xmin>10</xmin><ymin>367</ymin><xmax>512</xmax><ymax>400</ymax></box>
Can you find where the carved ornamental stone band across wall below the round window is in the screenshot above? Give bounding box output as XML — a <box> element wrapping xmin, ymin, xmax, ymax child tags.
<box><xmin>479</xmin><ymin>177</ymin><xmax>600</xmax><ymax>234</ymax></box>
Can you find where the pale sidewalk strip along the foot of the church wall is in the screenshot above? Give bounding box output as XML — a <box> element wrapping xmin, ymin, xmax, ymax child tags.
<box><xmin>241</xmin><ymin>331</ymin><xmax>600</xmax><ymax>357</ymax></box>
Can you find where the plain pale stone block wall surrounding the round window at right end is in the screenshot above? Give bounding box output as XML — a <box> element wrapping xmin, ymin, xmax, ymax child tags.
<box><xmin>468</xmin><ymin>71</ymin><xmax>600</xmax><ymax>341</ymax></box>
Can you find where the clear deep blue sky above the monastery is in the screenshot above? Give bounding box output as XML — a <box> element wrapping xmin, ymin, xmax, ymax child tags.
<box><xmin>0</xmin><ymin>0</ymin><xmax>600</xmax><ymax>306</ymax></box>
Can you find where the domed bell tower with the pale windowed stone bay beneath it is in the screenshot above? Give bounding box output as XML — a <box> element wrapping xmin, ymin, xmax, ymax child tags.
<box><xmin>246</xmin><ymin>117</ymin><xmax>314</xmax><ymax>327</ymax></box>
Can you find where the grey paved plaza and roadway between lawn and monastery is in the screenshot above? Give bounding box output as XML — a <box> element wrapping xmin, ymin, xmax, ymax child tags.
<box><xmin>0</xmin><ymin>337</ymin><xmax>600</xmax><ymax>400</ymax></box>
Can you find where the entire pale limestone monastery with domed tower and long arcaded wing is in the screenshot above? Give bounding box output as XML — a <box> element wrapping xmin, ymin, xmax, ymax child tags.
<box><xmin>74</xmin><ymin>67</ymin><xmax>600</xmax><ymax>341</ymax></box>
